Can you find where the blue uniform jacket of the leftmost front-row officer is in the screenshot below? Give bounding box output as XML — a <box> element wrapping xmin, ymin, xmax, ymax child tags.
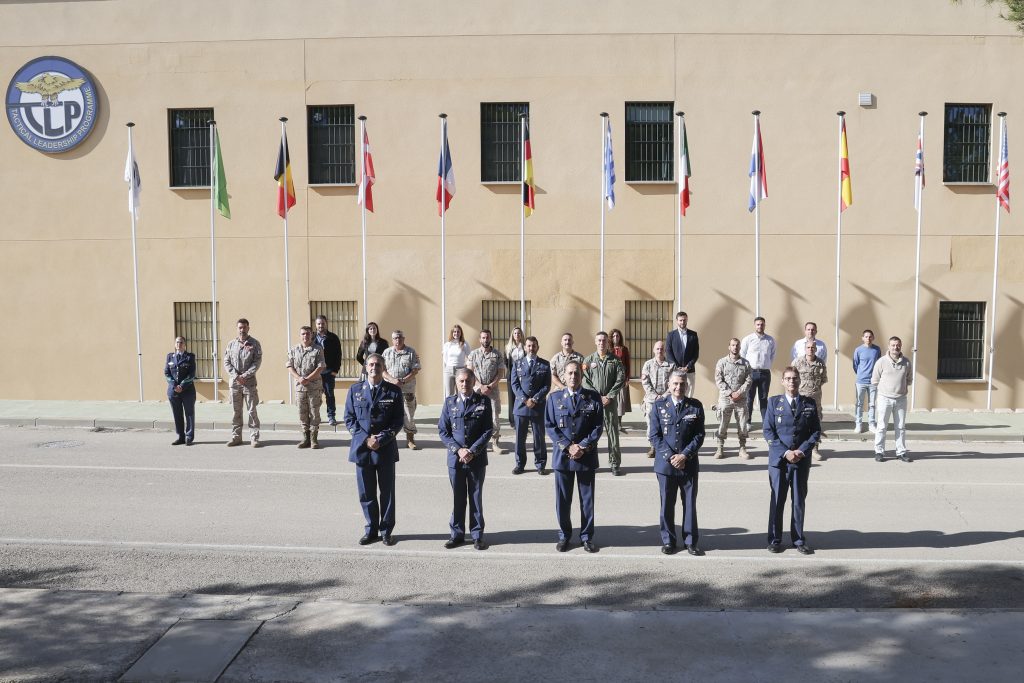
<box><xmin>345</xmin><ymin>380</ymin><xmax>403</xmax><ymax>465</ymax></box>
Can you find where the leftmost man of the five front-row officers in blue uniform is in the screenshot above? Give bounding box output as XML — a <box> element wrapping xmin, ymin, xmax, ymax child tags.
<box><xmin>345</xmin><ymin>353</ymin><xmax>402</xmax><ymax>546</ymax></box>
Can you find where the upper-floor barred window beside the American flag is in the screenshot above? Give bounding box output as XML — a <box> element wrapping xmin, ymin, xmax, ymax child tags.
<box><xmin>942</xmin><ymin>104</ymin><xmax>992</xmax><ymax>182</ymax></box>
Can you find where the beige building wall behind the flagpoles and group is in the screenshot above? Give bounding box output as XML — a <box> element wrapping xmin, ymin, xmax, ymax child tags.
<box><xmin>0</xmin><ymin>0</ymin><xmax>1024</xmax><ymax>409</ymax></box>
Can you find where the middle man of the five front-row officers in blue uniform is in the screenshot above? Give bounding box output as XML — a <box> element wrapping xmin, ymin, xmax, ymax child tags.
<box><xmin>544</xmin><ymin>360</ymin><xmax>604</xmax><ymax>553</ymax></box>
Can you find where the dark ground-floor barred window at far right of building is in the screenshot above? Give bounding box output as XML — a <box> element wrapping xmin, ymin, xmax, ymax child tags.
<box><xmin>937</xmin><ymin>301</ymin><xmax>985</xmax><ymax>380</ymax></box>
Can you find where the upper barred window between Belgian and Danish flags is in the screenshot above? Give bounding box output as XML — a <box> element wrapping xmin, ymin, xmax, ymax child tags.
<box><xmin>306</xmin><ymin>104</ymin><xmax>356</xmax><ymax>185</ymax></box>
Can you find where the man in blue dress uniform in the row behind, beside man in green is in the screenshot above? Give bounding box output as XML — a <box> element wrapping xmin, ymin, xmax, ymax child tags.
<box><xmin>511</xmin><ymin>337</ymin><xmax>551</xmax><ymax>474</ymax></box>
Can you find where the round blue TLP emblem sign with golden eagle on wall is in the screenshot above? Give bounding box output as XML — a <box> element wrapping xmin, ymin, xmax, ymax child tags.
<box><xmin>6</xmin><ymin>57</ymin><xmax>99</xmax><ymax>154</ymax></box>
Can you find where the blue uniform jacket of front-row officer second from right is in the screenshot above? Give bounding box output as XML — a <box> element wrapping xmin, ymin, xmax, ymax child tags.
<box><xmin>647</xmin><ymin>396</ymin><xmax>705</xmax><ymax>476</ymax></box>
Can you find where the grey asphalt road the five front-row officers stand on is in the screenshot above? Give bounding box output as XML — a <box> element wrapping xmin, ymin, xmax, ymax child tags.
<box><xmin>0</xmin><ymin>428</ymin><xmax>1024</xmax><ymax>609</ymax></box>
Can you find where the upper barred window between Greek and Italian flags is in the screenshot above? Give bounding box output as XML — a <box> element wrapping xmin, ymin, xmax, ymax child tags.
<box><xmin>626</xmin><ymin>102</ymin><xmax>675</xmax><ymax>182</ymax></box>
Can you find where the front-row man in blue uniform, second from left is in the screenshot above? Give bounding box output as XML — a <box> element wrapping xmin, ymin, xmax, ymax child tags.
<box><xmin>437</xmin><ymin>368</ymin><xmax>495</xmax><ymax>550</ymax></box>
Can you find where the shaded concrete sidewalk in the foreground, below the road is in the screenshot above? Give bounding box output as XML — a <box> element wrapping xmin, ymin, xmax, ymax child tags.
<box><xmin>0</xmin><ymin>589</ymin><xmax>1024</xmax><ymax>683</ymax></box>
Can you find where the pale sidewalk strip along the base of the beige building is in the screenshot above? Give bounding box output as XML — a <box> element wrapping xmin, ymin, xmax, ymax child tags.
<box><xmin>0</xmin><ymin>400</ymin><xmax>1024</xmax><ymax>443</ymax></box>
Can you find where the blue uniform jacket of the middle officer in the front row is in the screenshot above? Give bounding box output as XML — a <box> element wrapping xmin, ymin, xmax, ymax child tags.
<box><xmin>544</xmin><ymin>388</ymin><xmax>604</xmax><ymax>472</ymax></box>
